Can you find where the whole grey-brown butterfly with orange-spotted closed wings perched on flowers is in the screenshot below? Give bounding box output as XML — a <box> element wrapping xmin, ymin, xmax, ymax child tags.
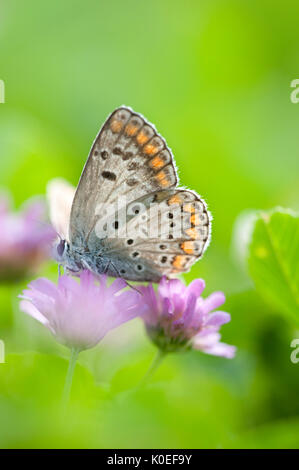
<box><xmin>48</xmin><ymin>106</ymin><xmax>211</xmax><ymax>282</ymax></box>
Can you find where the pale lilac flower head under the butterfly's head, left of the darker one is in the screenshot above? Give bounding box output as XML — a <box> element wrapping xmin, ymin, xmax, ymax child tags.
<box><xmin>20</xmin><ymin>271</ymin><xmax>140</xmax><ymax>351</ymax></box>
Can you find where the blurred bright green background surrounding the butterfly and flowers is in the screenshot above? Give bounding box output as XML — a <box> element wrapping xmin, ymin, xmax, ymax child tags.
<box><xmin>0</xmin><ymin>0</ymin><xmax>299</xmax><ymax>448</ymax></box>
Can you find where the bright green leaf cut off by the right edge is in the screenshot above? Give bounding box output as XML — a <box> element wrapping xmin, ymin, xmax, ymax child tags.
<box><xmin>248</xmin><ymin>208</ymin><xmax>299</xmax><ymax>324</ymax></box>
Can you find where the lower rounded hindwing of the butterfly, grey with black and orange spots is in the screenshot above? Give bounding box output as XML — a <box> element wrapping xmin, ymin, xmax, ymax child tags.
<box><xmin>91</xmin><ymin>189</ymin><xmax>211</xmax><ymax>282</ymax></box>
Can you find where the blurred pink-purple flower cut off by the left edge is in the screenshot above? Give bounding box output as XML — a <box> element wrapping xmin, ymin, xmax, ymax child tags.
<box><xmin>0</xmin><ymin>196</ymin><xmax>55</xmax><ymax>282</ymax></box>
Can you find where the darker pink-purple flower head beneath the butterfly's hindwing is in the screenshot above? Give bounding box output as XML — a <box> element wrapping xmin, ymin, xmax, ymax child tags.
<box><xmin>138</xmin><ymin>278</ymin><xmax>236</xmax><ymax>358</ymax></box>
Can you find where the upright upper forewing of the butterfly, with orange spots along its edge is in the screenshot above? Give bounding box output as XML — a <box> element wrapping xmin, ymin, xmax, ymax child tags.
<box><xmin>70</xmin><ymin>106</ymin><xmax>177</xmax><ymax>250</ymax></box>
